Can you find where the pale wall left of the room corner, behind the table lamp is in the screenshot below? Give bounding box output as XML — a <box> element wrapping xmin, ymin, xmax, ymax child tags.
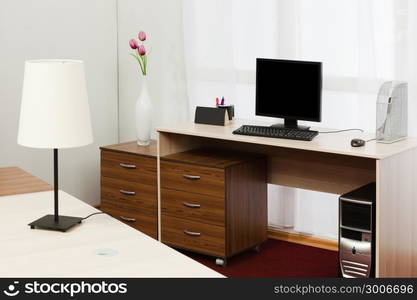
<box><xmin>0</xmin><ymin>0</ymin><xmax>118</xmax><ymax>204</ymax></box>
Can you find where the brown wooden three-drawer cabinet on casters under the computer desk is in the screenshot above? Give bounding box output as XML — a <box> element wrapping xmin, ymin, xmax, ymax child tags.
<box><xmin>160</xmin><ymin>149</ymin><xmax>267</xmax><ymax>260</ymax></box>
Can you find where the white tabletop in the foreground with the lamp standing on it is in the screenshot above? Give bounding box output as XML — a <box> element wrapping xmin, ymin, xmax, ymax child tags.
<box><xmin>0</xmin><ymin>191</ymin><xmax>223</xmax><ymax>277</ymax></box>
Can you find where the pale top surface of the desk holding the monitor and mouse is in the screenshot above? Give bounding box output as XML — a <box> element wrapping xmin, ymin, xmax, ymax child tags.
<box><xmin>157</xmin><ymin>119</ymin><xmax>417</xmax><ymax>159</ymax></box>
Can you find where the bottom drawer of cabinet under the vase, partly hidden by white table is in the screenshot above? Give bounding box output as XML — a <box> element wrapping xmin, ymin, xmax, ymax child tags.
<box><xmin>100</xmin><ymin>204</ymin><xmax>158</xmax><ymax>239</ymax></box>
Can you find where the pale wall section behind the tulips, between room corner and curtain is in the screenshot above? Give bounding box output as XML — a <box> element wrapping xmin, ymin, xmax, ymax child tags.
<box><xmin>118</xmin><ymin>0</ymin><xmax>188</xmax><ymax>142</ymax></box>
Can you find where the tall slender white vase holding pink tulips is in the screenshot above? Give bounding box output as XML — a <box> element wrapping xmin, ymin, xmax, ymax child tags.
<box><xmin>135</xmin><ymin>76</ymin><xmax>152</xmax><ymax>146</ymax></box>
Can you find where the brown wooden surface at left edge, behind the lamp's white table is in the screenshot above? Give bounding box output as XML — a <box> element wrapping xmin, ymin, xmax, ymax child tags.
<box><xmin>0</xmin><ymin>167</ymin><xmax>52</xmax><ymax>196</ymax></box>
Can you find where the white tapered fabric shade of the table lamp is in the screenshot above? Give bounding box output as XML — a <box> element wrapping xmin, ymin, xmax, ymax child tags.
<box><xmin>17</xmin><ymin>60</ymin><xmax>93</xmax><ymax>149</ymax></box>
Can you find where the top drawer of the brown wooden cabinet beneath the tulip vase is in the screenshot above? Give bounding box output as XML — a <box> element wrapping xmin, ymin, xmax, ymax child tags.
<box><xmin>101</xmin><ymin>150</ymin><xmax>157</xmax><ymax>186</ymax></box>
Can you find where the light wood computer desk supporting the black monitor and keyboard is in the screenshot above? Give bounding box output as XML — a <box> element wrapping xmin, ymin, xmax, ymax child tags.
<box><xmin>158</xmin><ymin>120</ymin><xmax>417</xmax><ymax>277</ymax></box>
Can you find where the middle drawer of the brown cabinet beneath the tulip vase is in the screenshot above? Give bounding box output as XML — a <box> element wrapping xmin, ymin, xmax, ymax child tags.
<box><xmin>101</xmin><ymin>177</ymin><xmax>157</xmax><ymax>213</ymax></box>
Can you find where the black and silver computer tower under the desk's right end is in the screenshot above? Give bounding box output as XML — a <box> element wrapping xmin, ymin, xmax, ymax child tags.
<box><xmin>339</xmin><ymin>182</ymin><xmax>376</xmax><ymax>278</ymax></box>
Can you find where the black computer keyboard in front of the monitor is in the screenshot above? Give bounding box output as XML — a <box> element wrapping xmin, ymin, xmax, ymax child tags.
<box><xmin>233</xmin><ymin>125</ymin><xmax>319</xmax><ymax>141</ymax></box>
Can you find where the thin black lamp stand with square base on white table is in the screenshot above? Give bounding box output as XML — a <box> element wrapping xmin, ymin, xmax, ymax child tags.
<box><xmin>29</xmin><ymin>149</ymin><xmax>83</xmax><ymax>232</ymax></box>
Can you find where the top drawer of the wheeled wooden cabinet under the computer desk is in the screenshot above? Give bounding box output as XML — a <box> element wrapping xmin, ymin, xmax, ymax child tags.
<box><xmin>161</xmin><ymin>160</ymin><xmax>224</xmax><ymax>198</ymax></box>
